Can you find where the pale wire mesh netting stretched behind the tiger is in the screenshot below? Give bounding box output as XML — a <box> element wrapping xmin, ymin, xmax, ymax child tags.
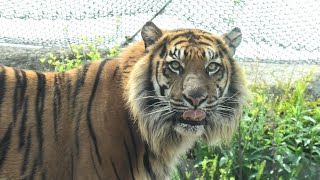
<box><xmin>0</xmin><ymin>0</ymin><xmax>320</xmax><ymax>64</ymax></box>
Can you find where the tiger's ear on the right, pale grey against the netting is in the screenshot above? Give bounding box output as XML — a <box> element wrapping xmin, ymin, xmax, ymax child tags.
<box><xmin>222</xmin><ymin>27</ymin><xmax>242</xmax><ymax>56</ymax></box>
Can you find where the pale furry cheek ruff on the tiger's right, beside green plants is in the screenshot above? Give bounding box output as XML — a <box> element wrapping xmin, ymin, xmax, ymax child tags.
<box><xmin>203</xmin><ymin>59</ymin><xmax>247</xmax><ymax>146</ymax></box>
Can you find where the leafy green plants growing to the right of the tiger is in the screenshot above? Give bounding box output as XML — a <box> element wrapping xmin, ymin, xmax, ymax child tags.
<box><xmin>175</xmin><ymin>71</ymin><xmax>320</xmax><ymax>180</ymax></box>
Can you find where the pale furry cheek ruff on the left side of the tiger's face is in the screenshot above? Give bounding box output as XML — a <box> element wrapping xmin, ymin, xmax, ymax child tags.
<box><xmin>126</xmin><ymin>56</ymin><xmax>179</xmax><ymax>152</ymax></box>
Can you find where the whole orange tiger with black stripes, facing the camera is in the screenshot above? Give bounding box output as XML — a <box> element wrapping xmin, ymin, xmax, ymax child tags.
<box><xmin>0</xmin><ymin>22</ymin><xmax>246</xmax><ymax>180</ymax></box>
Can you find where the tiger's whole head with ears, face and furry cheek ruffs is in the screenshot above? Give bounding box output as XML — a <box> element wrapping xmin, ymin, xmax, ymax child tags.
<box><xmin>125</xmin><ymin>22</ymin><xmax>245</xmax><ymax>156</ymax></box>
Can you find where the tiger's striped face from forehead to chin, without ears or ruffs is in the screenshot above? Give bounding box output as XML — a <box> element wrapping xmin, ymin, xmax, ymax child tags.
<box><xmin>153</xmin><ymin>41</ymin><xmax>230</xmax><ymax>135</ymax></box>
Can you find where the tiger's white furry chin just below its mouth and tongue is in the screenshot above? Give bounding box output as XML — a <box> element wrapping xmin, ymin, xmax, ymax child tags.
<box><xmin>174</xmin><ymin>122</ymin><xmax>205</xmax><ymax>136</ymax></box>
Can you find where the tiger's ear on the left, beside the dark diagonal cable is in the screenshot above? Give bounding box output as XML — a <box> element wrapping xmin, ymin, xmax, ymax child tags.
<box><xmin>141</xmin><ymin>21</ymin><xmax>162</xmax><ymax>48</ymax></box>
